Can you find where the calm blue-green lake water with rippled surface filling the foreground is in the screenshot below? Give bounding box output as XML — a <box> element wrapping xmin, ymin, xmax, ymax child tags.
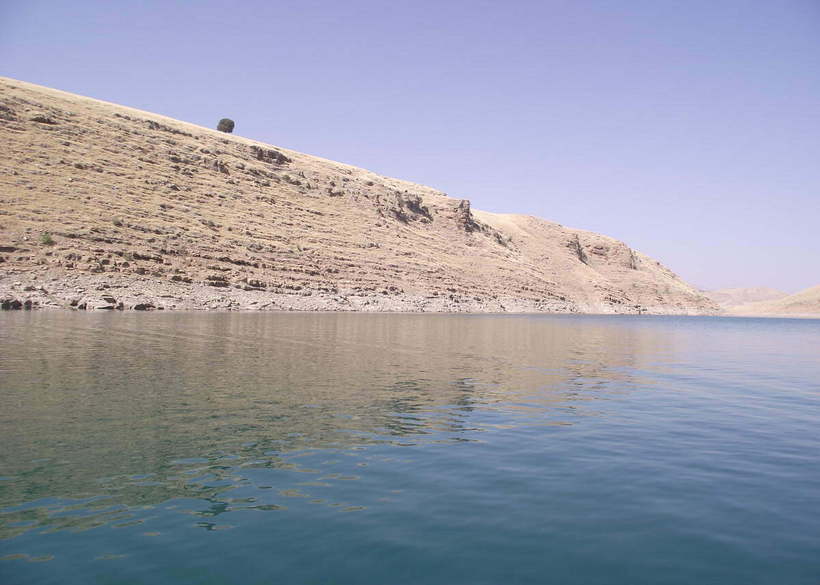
<box><xmin>0</xmin><ymin>312</ymin><xmax>820</xmax><ymax>585</ymax></box>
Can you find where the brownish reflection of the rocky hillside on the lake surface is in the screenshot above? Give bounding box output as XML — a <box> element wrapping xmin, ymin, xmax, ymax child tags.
<box><xmin>0</xmin><ymin>313</ymin><xmax>670</xmax><ymax>532</ymax></box>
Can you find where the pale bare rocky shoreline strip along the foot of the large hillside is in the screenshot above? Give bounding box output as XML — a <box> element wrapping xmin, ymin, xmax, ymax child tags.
<box><xmin>0</xmin><ymin>273</ymin><xmax>717</xmax><ymax>316</ymax></box>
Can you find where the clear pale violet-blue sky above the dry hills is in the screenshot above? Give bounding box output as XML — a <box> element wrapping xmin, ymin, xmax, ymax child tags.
<box><xmin>0</xmin><ymin>0</ymin><xmax>820</xmax><ymax>292</ymax></box>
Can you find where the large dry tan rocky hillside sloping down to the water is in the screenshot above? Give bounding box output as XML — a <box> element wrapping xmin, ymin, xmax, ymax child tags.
<box><xmin>0</xmin><ymin>78</ymin><xmax>716</xmax><ymax>314</ymax></box>
